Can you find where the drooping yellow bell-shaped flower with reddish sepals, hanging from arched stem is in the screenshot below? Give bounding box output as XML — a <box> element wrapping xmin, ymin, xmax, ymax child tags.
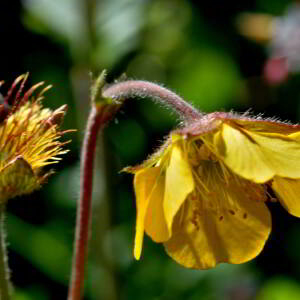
<box><xmin>125</xmin><ymin>113</ymin><xmax>300</xmax><ymax>269</ymax></box>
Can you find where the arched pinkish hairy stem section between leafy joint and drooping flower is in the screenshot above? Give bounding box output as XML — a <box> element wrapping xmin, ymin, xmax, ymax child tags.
<box><xmin>103</xmin><ymin>80</ymin><xmax>203</xmax><ymax>121</ymax></box>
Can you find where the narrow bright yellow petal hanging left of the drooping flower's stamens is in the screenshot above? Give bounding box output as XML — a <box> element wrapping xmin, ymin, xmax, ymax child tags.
<box><xmin>164</xmin><ymin>143</ymin><xmax>194</xmax><ymax>236</ymax></box>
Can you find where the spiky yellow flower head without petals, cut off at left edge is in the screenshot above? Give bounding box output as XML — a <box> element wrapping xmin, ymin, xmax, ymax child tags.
<box><xmin>0</xmin><ymin>74</ymin><xmax>67</xmax><ymax>203</ymax></box>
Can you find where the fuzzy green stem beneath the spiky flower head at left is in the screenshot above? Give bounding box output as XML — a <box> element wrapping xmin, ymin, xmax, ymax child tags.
<box><xmin>0</xmin><ymin>204</ymin><xmax>11</xmax><ymax>300</ymax></box>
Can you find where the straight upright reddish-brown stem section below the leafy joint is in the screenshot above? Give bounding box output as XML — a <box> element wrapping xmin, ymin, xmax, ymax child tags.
<box><xmin>68</xmin><ymin>105</ymin><xmax>117</xmax><ymax>300</ymax></box>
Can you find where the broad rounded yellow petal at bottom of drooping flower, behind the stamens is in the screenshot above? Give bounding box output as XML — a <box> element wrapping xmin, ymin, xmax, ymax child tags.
<box><xmin>165</xmin><ymin>161</ymin><xmax>271</xmax><ymax>269</ymax></box>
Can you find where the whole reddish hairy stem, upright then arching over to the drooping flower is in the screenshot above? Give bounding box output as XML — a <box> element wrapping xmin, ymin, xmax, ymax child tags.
<box><xmin>68</xmin><ymin>77</ymin><xmax>203</xmax><ymax>300</ymax></box>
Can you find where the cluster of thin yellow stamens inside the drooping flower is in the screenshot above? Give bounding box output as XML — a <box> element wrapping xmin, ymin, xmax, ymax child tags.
<box><xmin>187</xmin><ymin>143</ymin><xmax>267</xmax><ymax>228</ymax></box>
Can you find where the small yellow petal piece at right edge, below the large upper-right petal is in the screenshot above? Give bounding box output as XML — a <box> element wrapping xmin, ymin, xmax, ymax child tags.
<box><xmin>272</xmin><ymin>176</ymin><xmax>300</xmax><ymax>217</ymax></box>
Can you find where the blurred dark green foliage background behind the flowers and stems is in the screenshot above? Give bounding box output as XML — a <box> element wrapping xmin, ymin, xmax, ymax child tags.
<box><xmin>0</xmin><ymin>0</ymin><xmax>300</xmax><ymax>300</ymax></box>
